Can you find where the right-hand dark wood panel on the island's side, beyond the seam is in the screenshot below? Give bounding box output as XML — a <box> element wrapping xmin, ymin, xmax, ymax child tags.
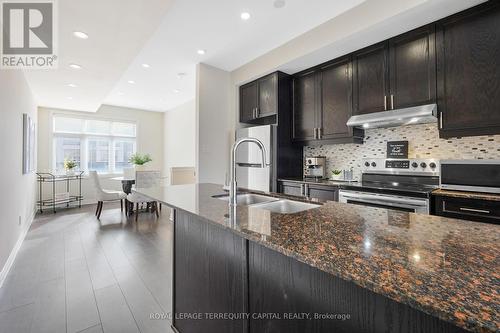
<box><xmin>248</xmin><ymin>242</ymin><xmax>465</xmax><ymax>333</ymax></box>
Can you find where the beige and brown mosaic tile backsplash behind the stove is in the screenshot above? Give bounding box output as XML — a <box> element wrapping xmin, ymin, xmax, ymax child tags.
<box><xmin>304</xmin><ymin>124</ymin><xmax>500</xmax><ymax>179</ymax></box>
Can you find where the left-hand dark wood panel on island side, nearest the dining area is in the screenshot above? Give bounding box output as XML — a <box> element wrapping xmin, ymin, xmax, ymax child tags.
<box><xmin>173</xmin><ymin>211</ymin><xmax>247</xmax><ymax>333</ymax></box>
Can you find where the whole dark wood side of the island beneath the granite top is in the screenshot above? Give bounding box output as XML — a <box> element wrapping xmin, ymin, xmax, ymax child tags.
<box><xmin>173</xmin><ymin>211</ymin><xmax>465</xmax><ymax>333</ymax></box>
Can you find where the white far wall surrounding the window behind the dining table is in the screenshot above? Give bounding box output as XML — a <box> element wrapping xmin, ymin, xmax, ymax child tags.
<box><xmin>38</xmin><ymin>105</ymin><xmax>163</xmax><ymax>204</ymax></box>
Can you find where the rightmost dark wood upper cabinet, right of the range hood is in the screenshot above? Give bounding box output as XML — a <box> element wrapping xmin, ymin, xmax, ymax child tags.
<box><xmin>436</xmin><ymin>1</ymin><xmax>500</xmax><ymax>138</ymax></box>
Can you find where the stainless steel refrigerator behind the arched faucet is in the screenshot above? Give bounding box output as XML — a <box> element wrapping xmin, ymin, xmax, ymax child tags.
<box><xmin>236</xmin><ymin>125</ymin><xmax>276</xmax><ymax>192</ymax></box>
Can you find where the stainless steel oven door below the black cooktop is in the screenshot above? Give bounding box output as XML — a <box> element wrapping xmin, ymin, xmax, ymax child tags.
<box><xmin>339</xmin><ymin>190</ymin><xmax>430</xmax><ymax>214</ymax></box>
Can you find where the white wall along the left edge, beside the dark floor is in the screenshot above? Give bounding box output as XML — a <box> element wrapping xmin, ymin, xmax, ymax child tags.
<box><xmin>0</xmin><ymin>70</ymin><xmax>38</xmax><ymax>285</ymax></box>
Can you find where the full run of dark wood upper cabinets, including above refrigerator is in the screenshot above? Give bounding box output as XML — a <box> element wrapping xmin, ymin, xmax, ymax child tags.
<box><xmin>249</xmin><ymin>1</ymin><xmax>500</xmax><ymax>144</ymax></box>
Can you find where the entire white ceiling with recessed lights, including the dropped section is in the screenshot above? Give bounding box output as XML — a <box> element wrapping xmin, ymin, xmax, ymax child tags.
<box><xmin>21</xmin><ymin>0</ymin><xmax>364</xmax><ymax>112</ymax></box>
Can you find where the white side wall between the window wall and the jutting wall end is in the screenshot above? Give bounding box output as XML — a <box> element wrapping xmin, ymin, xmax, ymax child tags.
<box><xmin>163</xmin><ymin>99</ymin><xmax>196</xmax><ymax>183</ymax></box>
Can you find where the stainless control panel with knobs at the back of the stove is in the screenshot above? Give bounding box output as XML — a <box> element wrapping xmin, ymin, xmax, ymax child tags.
<box><xmin>362</xmin><ymin>158</ymin><xmax>440</xmax><ymax>176</ymax></box>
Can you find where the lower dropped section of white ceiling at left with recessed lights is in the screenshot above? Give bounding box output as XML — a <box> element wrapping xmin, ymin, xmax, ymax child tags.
<box><xmin>25</xmin><ymin>0</ymin><xmax>172</xmax><ymax>112</ymax></box>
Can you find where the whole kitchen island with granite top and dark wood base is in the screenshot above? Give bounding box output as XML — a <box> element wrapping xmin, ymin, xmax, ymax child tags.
<box><xmin>136</xmin><ymin>184</ymin><xmax>500</xmax><ymax>333</ymax></box>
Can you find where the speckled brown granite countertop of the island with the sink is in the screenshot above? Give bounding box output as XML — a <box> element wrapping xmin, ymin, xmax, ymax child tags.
<box><xmin>137</xmin><ymin>184</ymin><xmax>500</xmax><ymax>332</ymax></box>
